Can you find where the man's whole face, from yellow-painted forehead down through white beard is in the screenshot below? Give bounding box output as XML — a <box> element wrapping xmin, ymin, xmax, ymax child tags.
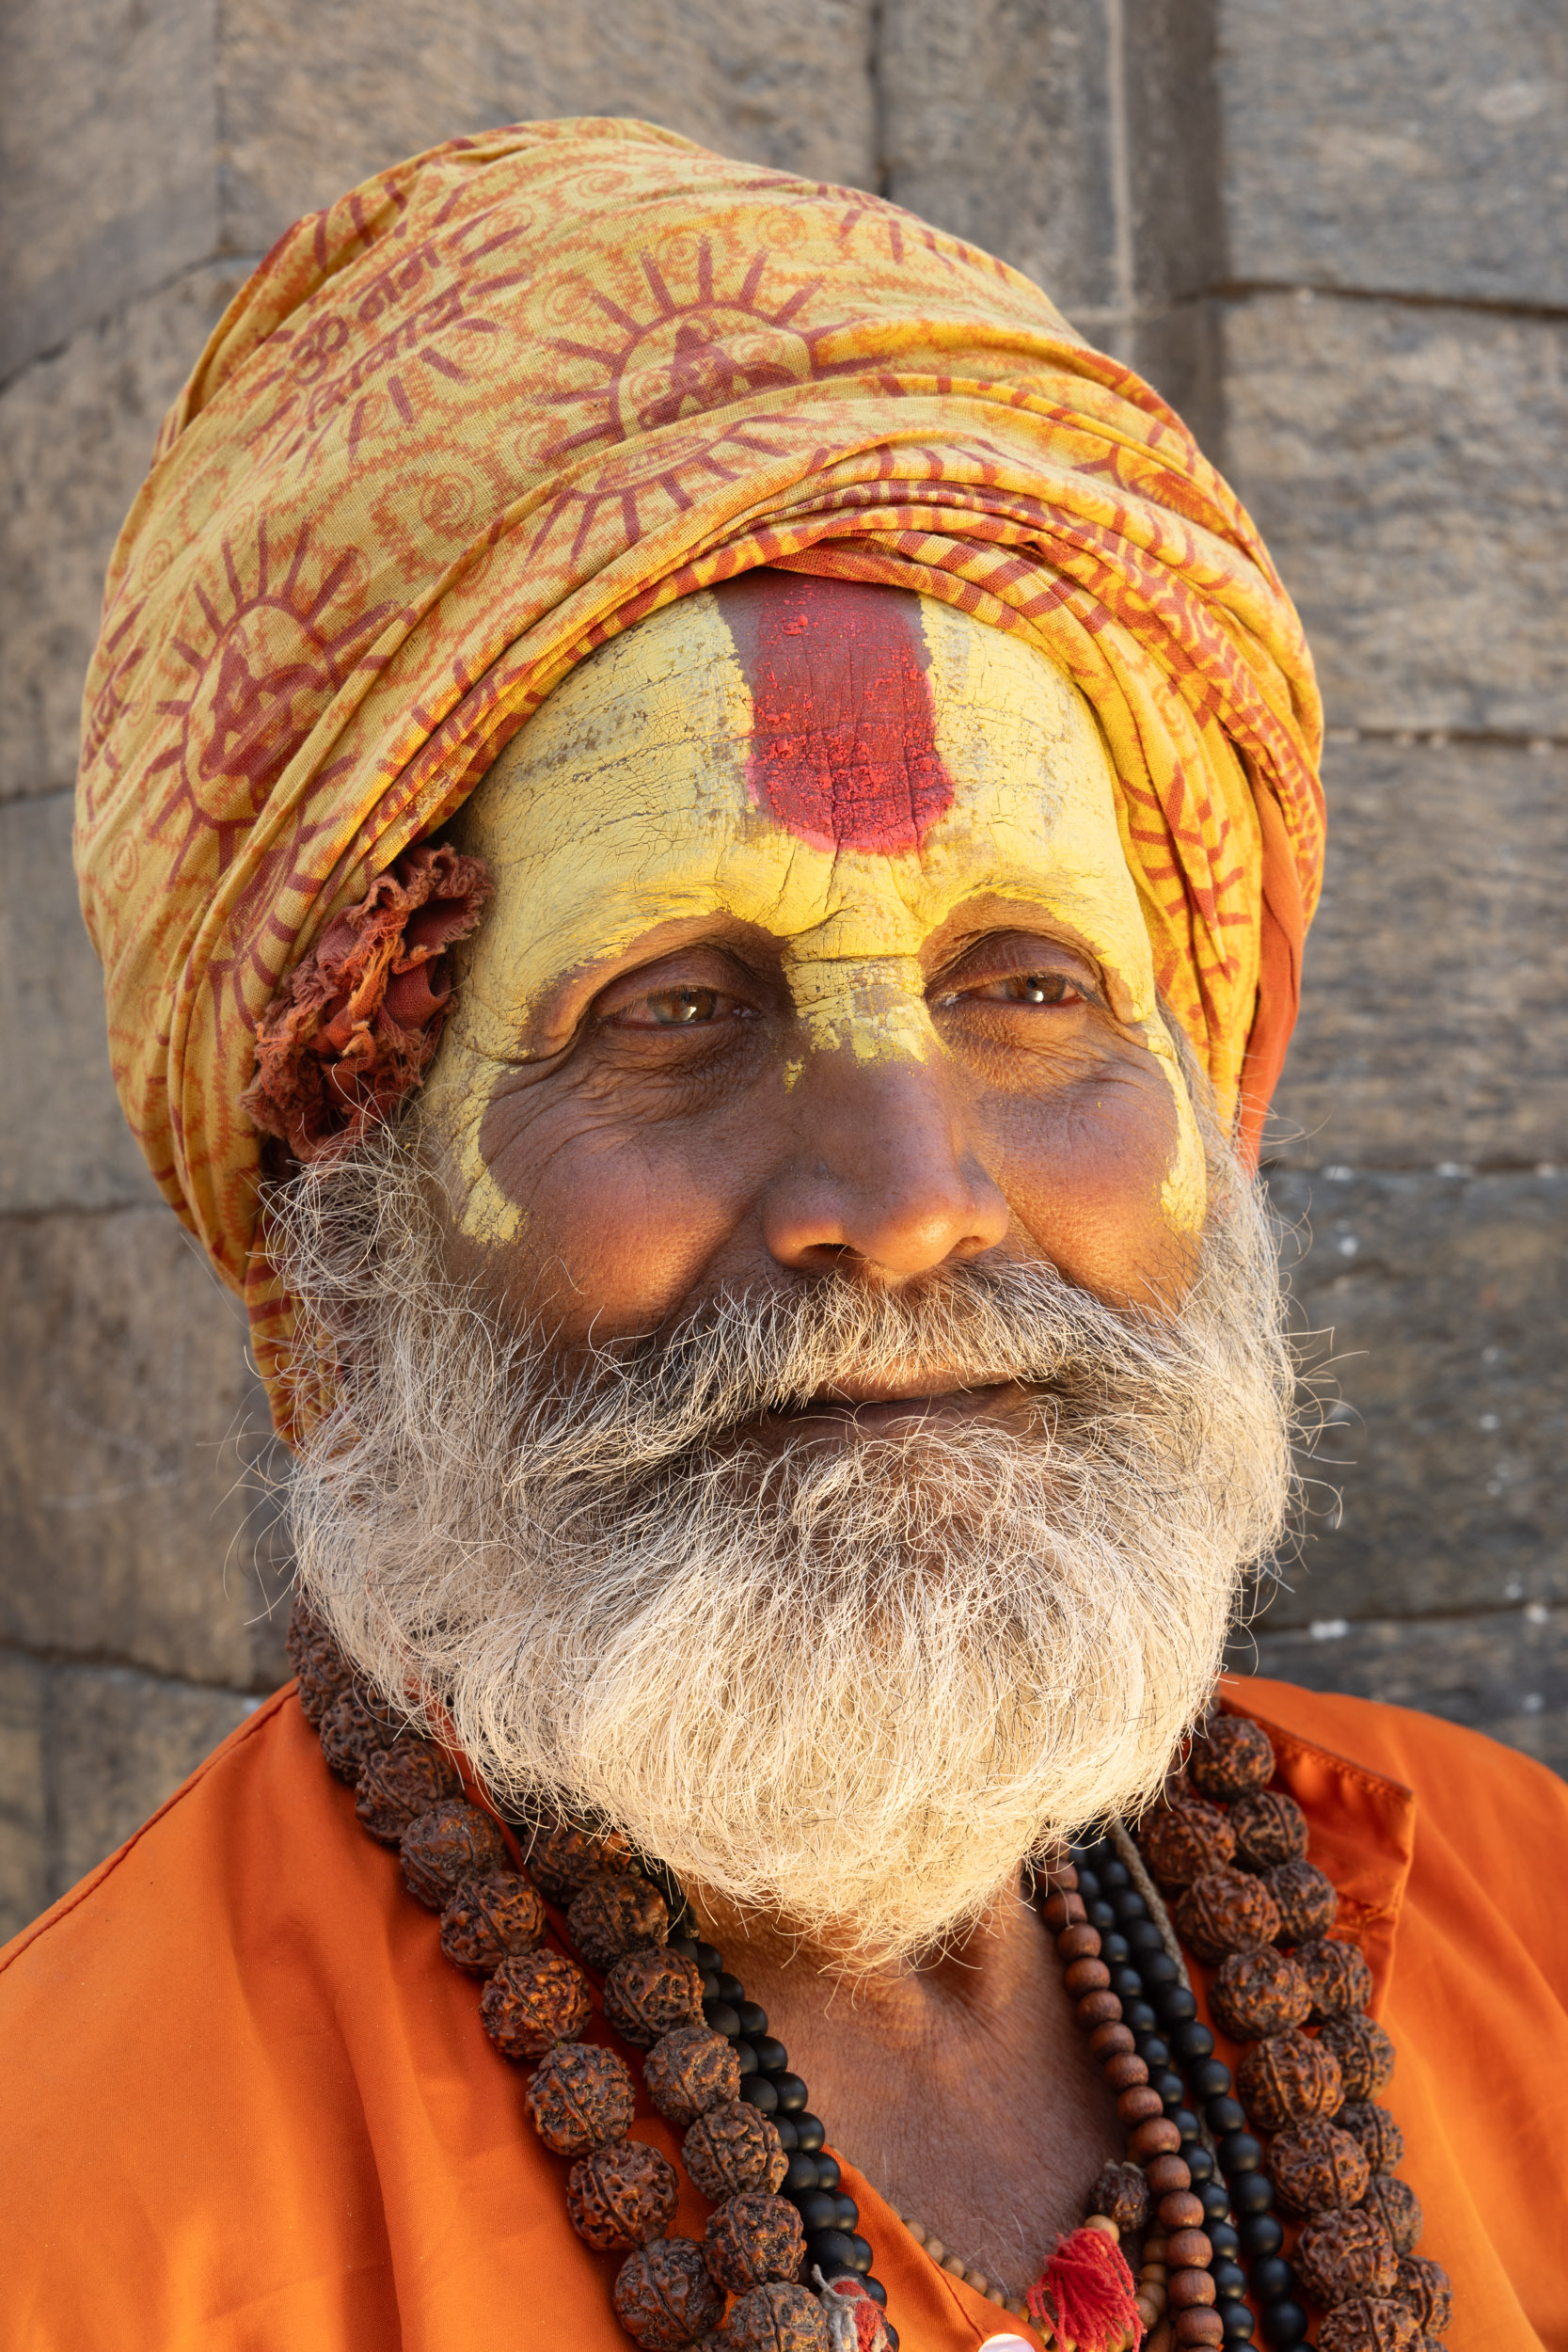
<box><xmin>277</xmin><ymin>574</ymin><xmax>1289</xmax><ymax>1957</ymax></box>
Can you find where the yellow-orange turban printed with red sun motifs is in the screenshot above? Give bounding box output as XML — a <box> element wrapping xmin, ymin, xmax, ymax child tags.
<box><xmin>77</xmin><ymin>120</ymin><xmax>1323</xmax><ymax>1421</ymax></box>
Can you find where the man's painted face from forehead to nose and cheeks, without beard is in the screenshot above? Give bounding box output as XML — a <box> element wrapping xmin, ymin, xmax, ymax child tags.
<box><xmin>425</xmin><ymin>572</ymin><xmax>1204</xmax><ymax>1425</ymax></box>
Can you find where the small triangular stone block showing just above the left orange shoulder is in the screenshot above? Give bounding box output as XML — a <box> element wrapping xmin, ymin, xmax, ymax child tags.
<box><xmin>52</xmin><ymin>1665</ymin><xmax>259</xmax><ymax>1899</ymax></box>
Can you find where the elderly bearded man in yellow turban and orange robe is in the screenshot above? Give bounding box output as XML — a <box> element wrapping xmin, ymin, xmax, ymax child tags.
<box><xmin>0</xmin><ymin>122</ymin><xmax>1568</xmax><ymax>2352</ymax></box>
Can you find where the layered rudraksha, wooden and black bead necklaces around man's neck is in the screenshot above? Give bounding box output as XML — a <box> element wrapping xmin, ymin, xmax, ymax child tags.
<box><xmin>289</xmin><ymin>1609</ymin><xmax>1449</xmax><ymax>2352</ymax></box>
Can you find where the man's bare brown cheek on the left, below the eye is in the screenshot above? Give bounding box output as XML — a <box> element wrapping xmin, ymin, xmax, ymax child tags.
<box><xmin>482</xmin><ymin>1094</ymin><xmax>754</xmax><ymax>1341</ymax></box>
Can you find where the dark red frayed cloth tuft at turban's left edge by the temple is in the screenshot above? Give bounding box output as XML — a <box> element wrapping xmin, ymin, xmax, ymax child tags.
<box><xmin>240</xmin><ymin>845</ymin><xmax>494</xmax><ymax>1160</ymax></box>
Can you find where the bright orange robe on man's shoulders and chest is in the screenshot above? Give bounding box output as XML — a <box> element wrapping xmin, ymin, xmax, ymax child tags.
<box><xmin>0</xmin><ymin>1682</ymin><xmax>1568</xmax><ymax>2352</ymax></box>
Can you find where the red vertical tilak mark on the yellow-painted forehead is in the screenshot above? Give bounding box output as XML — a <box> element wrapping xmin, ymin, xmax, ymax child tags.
<box><xmin>720</xmin><ymin>569</ymin><xmax>952</xmax><ymax>856</ymax></box>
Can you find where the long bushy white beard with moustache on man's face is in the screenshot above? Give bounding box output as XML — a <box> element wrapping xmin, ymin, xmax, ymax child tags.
<box><xmin>275</xmin><ymin>1134</ymin><xmax>1291</xmax><ymax>1966</ymax></box>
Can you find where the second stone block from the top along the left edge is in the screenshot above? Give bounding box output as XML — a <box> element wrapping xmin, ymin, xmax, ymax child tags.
<box><xmin>0</xmin><ymin>263</ymin><xmax>242</xmax><ymax>798</ymax></box>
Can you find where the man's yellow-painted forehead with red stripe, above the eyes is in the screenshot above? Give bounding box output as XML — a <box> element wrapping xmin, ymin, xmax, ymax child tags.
<box><xmin>463</xmin><ymin>572</ymin><xmax>1148</xmax><ymax>995</ymax></box>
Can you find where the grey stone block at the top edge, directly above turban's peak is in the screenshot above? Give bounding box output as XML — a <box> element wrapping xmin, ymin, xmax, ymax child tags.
<box><xmin>218</xmin><ymin>0</ymin><xmax>875</xmax><ymax>249</ymax></box>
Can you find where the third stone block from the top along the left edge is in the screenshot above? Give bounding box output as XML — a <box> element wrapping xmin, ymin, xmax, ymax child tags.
<box><xmin>0</xmin><ymin>793</ymin><xmax>157</xmax><ymax>1212</ymax></box>
